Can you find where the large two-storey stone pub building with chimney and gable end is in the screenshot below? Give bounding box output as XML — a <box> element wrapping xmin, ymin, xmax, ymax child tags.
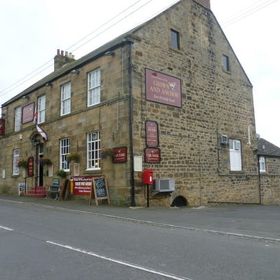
<box><xmin>0</xmin><ymin>0</ymin><xmax>260</xmax><ymax>206</ymax></box>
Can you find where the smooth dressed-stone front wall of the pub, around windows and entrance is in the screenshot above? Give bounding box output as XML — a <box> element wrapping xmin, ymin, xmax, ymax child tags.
<box><xmin>0</xmin><ymin>44</ymin><xmax>133</xmax><ymax>204</ymax></box>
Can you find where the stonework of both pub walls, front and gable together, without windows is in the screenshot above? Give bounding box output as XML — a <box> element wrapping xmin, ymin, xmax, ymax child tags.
<box><xmin>0</xmin><ymin>0</ymin><xmax>259</xmax><ymax>206</ymax></box>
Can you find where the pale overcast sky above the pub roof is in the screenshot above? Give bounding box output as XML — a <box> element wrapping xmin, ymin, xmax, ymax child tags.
<box><xmin>0</xmin><ymin>0</ymin><xmax>280</xmax><ymax>147</ymax></box>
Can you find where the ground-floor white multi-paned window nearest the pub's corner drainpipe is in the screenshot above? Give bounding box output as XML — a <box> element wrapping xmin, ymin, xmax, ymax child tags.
<box><xmin>87</xmin><ymin>131</ymin><xmax>100</xmax><ymax>170</ymax></box>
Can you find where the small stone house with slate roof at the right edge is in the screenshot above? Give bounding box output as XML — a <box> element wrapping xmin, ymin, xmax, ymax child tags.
<box><xmin>258</xmin><ymin>138</ymin><xmax>280</xmax><ymax>204</ymax></box>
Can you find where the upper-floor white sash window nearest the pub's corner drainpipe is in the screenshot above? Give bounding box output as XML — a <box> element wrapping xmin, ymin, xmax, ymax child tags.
<box><xmin>87</xmin><ymin>69</ymin><xmax>101</xmax><ymax>107</ymax></box>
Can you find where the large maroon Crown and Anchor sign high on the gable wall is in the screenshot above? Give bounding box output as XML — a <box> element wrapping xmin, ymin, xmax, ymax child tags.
<box><xmin>146</xmin><ymin>69</ymin><xmax>182</xmax><ymax>107</ymax></box>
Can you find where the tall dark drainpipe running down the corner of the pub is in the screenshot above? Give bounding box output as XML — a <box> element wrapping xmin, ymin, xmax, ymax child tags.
<box><xmin>128</xmin><ymin>40</ymin><xmax>136</xmax><ymax>207</ymax></box>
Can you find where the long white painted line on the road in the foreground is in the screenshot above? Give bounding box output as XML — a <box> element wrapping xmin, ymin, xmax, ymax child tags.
<box><xmin>46</xmin><ymin>241</ymin><xmax>192</xmax><ymax>280</ymax></box>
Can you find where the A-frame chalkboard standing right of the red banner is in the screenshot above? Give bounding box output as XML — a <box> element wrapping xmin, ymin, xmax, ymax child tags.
<box><xmin>89</xmin><ymin>176</ymin><xmax>110</xmax><ymax>206</ymax></box>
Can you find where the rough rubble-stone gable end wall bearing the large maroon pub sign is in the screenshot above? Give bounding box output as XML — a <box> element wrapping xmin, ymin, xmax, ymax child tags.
<box><xmin>129</xmin><ymin>1</ymin><xmax>259</xmax><ymax>205</ymax></box>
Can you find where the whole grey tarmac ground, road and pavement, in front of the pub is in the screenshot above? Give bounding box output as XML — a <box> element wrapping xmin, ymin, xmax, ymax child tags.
<box><xmin>0</xmin><ymin>197</ymin><xmax>280</xmax><ymax>280</ymax></box>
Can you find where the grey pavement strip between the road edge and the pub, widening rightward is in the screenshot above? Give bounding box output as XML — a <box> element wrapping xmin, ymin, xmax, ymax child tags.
<box><xmin>0</xmin><ymin>195</ymin><xmax>280</xmax><ymax>243</ymax></box>
